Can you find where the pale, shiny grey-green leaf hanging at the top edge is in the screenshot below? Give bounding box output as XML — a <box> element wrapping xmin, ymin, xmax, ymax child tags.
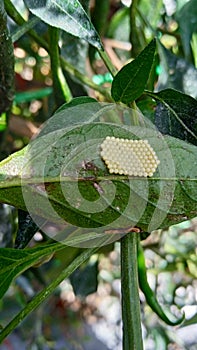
<box><xmin>25</xmin><ymin>0</ymin><xmax>103</xmax><ymax>50</ymax></box>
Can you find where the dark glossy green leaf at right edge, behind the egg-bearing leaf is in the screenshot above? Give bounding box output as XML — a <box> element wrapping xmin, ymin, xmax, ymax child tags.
<box><xmin>147</xmin><ymin>89</ymin><xmax>197</xmax><ymax>145</ymax></box>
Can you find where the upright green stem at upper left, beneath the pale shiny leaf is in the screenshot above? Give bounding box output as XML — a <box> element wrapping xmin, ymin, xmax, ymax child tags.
<box><xmin>49</xmin><ymin>27</ymin><xmax>72</xmax><ymax>107</ymax></box>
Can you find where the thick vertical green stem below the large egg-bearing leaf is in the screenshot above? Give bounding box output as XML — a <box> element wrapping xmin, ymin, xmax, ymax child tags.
<box><xmin>121</xmin><ymin>232</ymin><xmax>143</xmax><ymax>350</ymax></box>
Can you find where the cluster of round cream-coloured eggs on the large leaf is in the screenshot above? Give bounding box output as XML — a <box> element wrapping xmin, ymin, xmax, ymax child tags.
<box><xmin>101</xmin><ymin>136</ymin><xmax>160</xmax><ymax>177</ymax></box>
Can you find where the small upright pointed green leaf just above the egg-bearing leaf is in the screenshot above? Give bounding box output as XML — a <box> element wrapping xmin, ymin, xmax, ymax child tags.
<box><xmin>111</xmin><ymin>39</ymin><xmax>156</xmax><ymax>104</ymax></box>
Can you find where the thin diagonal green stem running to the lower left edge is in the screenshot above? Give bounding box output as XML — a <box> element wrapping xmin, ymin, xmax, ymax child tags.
<box><xmin>0</xmin><ymin>248</ymin><xmax>99</xmax><ymax>343</ymax></box>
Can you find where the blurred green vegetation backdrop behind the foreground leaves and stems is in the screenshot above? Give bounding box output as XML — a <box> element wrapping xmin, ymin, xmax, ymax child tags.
<box><xmin>0</xmin><ymin>0</ymin><xmax>197</xmax><ymax>350</ymax></box>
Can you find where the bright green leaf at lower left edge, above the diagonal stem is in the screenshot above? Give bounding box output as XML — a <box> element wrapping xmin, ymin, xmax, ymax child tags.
<box><xmin>0</xmin><ymin>243</ymin><xmax>65</xmax><ymax>299</ymax></box>
